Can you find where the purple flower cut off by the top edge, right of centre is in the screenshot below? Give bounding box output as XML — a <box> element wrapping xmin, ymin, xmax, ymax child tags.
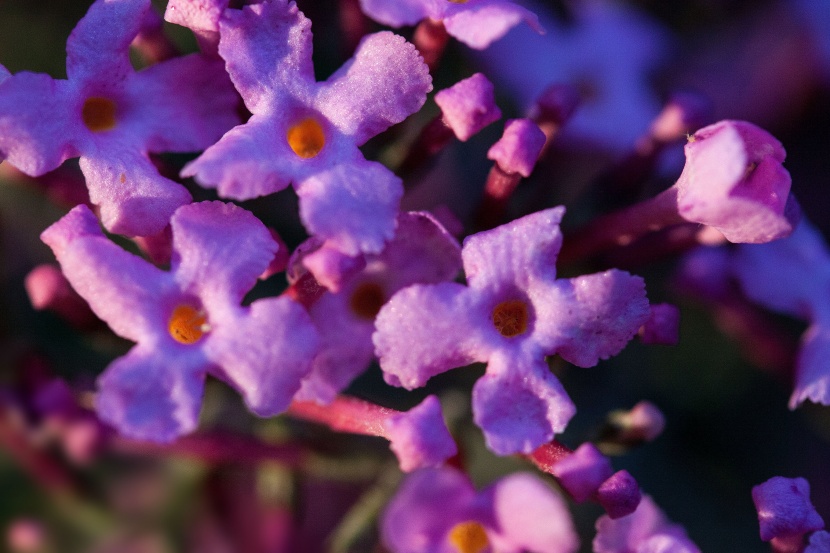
<box><xmin>360</xmin><ymin>0</ymin><xmax>544</xmax><ymax>50</ymax></box>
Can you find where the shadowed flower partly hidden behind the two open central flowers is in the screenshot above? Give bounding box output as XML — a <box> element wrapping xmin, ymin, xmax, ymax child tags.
<box><xmin>297</xmin><ymin>213</ymin><xmax>461</xmax><ymax>403</ymax></box>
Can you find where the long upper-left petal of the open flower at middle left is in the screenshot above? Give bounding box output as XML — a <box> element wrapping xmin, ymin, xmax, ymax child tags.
<box><xmin>41</xmin><ymin>205</ymin><xmax>180</xmax><ymax>342</ymax></box>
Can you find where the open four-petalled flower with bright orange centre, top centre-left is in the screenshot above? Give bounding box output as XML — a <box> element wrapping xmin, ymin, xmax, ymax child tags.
<box><xmin>182</xmin><ymin>0</ymin><xmax>432</xmax><ymax>255</ymax></box>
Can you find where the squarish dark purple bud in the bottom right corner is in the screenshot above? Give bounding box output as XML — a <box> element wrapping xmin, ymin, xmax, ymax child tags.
<box><xmin>752</xmin><ymin>476</ymin><xmax>824</xmax><ymax>541</ymax></box>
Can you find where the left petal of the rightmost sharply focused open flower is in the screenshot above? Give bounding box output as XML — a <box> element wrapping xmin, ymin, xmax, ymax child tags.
<box><xmin>372</xmin><ymin>282</ymin><xmax>489</xmax><ymax>390</ymax></box>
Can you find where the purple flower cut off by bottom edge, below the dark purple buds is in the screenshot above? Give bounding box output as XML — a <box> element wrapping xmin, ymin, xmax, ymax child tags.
<box><xmin>594</xmin><ymin>496</ymin><xmax>700</xmax><ymax>553</ymax></box>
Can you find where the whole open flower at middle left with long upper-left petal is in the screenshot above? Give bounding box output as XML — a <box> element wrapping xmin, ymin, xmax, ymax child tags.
<box><xmin>41</xmin><ymin>202</ymin><xmax>319</xmax><ymax>441</ymax></box>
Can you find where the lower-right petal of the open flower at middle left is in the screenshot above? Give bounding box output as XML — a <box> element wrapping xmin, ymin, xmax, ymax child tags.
<box><xmin>204</xmin><ymin>297</ymin><xmax>319</xmax><ymax>417</ymax></box>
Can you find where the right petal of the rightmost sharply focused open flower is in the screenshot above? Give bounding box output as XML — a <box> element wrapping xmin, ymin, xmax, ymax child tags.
<box><xmin>529</xmin><ymin>269</ymin><xmax>650</xmax><ymax>367</ymax></box>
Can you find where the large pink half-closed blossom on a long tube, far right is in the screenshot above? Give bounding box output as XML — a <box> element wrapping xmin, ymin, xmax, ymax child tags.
<box><xmin>674</xmin><ymin>121</ymin><xmax>798</xmax><ymax>243</ymax></box>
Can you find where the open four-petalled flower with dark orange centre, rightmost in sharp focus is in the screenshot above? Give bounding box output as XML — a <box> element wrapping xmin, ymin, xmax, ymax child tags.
<box><xmin>373</xmin><ymin>207</ymin><xmax>649</xmax><ymax>454</ymax></box>
